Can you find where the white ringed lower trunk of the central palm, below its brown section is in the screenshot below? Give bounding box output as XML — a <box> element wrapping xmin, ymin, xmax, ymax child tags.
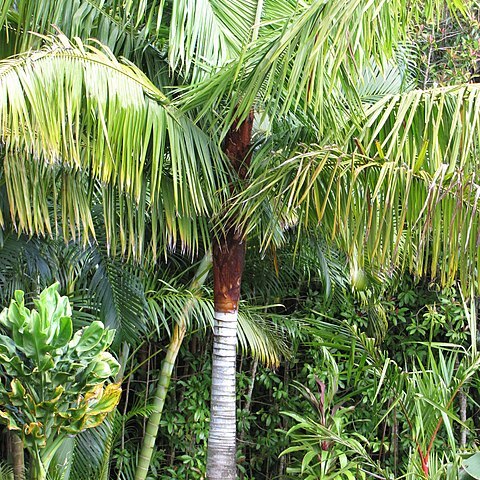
<box><xmin>207</xmin><ymin>310</ymin><xmax>238</xmax><ymax>480</ymax></box>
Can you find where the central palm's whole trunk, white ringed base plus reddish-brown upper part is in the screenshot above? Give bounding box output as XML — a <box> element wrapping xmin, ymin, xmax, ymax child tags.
<box><xmin>207</xmin><ymin>111</ymin><xmax>253</xmax><ymax>480</ymax></box>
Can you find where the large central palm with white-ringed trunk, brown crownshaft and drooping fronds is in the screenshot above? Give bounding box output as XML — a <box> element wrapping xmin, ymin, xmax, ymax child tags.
<box><xmin>0</xmin><ymin>0</ymin><xmax>480</xmax><ymax>479</ymax></box>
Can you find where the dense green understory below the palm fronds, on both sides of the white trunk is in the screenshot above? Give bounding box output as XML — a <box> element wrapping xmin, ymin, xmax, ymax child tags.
<box><xmin>2</xmin><ymin>242</ymin><xmax>480</xmax><ymax>480</ymax></box>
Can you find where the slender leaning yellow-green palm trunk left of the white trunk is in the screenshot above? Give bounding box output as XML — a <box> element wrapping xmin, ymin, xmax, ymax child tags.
<box><xmin>135</xmin><ymin>253</ymin><xmax>212</xmax><ymax>480</ymax></box>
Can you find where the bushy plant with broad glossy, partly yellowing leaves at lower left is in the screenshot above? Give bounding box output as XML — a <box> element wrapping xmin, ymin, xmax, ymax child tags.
<box><xmin>0</xmin><ymin>284</ymin><xmax>121</xmax><ymax>480</ymax></box>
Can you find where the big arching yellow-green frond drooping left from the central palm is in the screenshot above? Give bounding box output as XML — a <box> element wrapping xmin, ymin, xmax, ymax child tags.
<box><xmin>0</xmin><ymin>32</ymin><xmax>228</xmax><ymax>255</ymax></box>
